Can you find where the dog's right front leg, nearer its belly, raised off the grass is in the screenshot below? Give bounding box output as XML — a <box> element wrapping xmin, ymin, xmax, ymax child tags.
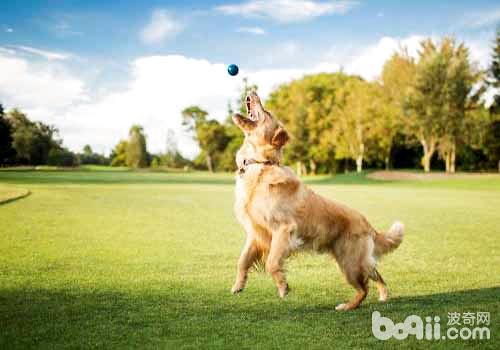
<box><xmin>266</xmin><ymin>225</ymin><xmax>293</xmax><ymax>298</ymax></box>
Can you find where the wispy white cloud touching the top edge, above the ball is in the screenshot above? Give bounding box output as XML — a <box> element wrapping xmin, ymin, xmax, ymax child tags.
<box><xmin>216</xmin><ymin>0</ymin><xmax>357</xmax><ymax>23</ymax></box>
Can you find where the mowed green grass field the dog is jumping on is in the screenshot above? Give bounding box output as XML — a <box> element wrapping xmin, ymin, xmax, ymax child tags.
<box><xmin>0</xmin><ymin>171</ymin><xmax>500</xmax><ymax>349</ymax></box>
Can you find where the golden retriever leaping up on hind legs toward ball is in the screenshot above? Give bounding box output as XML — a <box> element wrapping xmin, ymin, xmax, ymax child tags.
<box><xmin>231</xmin><ymin>92</ymin><xmax>404</xmax><ymax>311</ymax></box>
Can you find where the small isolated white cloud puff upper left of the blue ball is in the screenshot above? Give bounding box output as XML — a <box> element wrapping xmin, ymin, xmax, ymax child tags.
<box><xmin>141</xmin><ymin>10</ymin><xmax>182</xmax><ymax>44</ymax></box>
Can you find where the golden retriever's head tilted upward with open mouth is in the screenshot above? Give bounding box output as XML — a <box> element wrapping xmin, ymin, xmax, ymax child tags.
<box><xmin>233</xmin><ymin>92</ymin><xmax>289</xmax><ymax>168</ymax></box>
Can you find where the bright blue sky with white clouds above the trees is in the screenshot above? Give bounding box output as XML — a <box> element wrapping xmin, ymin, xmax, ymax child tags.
<box><xmin>0</xmin><ymin>0</ymin><xmax>500</xmax><ymax>155</ymax></box>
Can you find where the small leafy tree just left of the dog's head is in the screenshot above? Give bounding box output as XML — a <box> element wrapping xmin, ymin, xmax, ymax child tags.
<box><xmin>182</xmin><ymin>106</ymin><xmax>229</xmax><ymax>172</ymax></box>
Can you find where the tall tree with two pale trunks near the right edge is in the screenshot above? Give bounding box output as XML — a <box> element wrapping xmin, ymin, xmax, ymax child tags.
<box><xmin>407</xmin><ymin>38</ymin><xmax>479</xmax><ymax>172</ymax></box>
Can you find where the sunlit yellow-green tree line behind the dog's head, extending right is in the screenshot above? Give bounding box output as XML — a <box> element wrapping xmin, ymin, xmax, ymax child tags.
<box><xmin>187</xmin><ymin>34</ymin><xmax>500</xmax><ymax>174</ymax></box>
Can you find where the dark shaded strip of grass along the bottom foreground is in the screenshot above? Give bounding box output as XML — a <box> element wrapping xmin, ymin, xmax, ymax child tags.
<box><xmin>0</xmin><ymin>285</ymin><xmax>500</xmax><ymax>349</ymax></box>
